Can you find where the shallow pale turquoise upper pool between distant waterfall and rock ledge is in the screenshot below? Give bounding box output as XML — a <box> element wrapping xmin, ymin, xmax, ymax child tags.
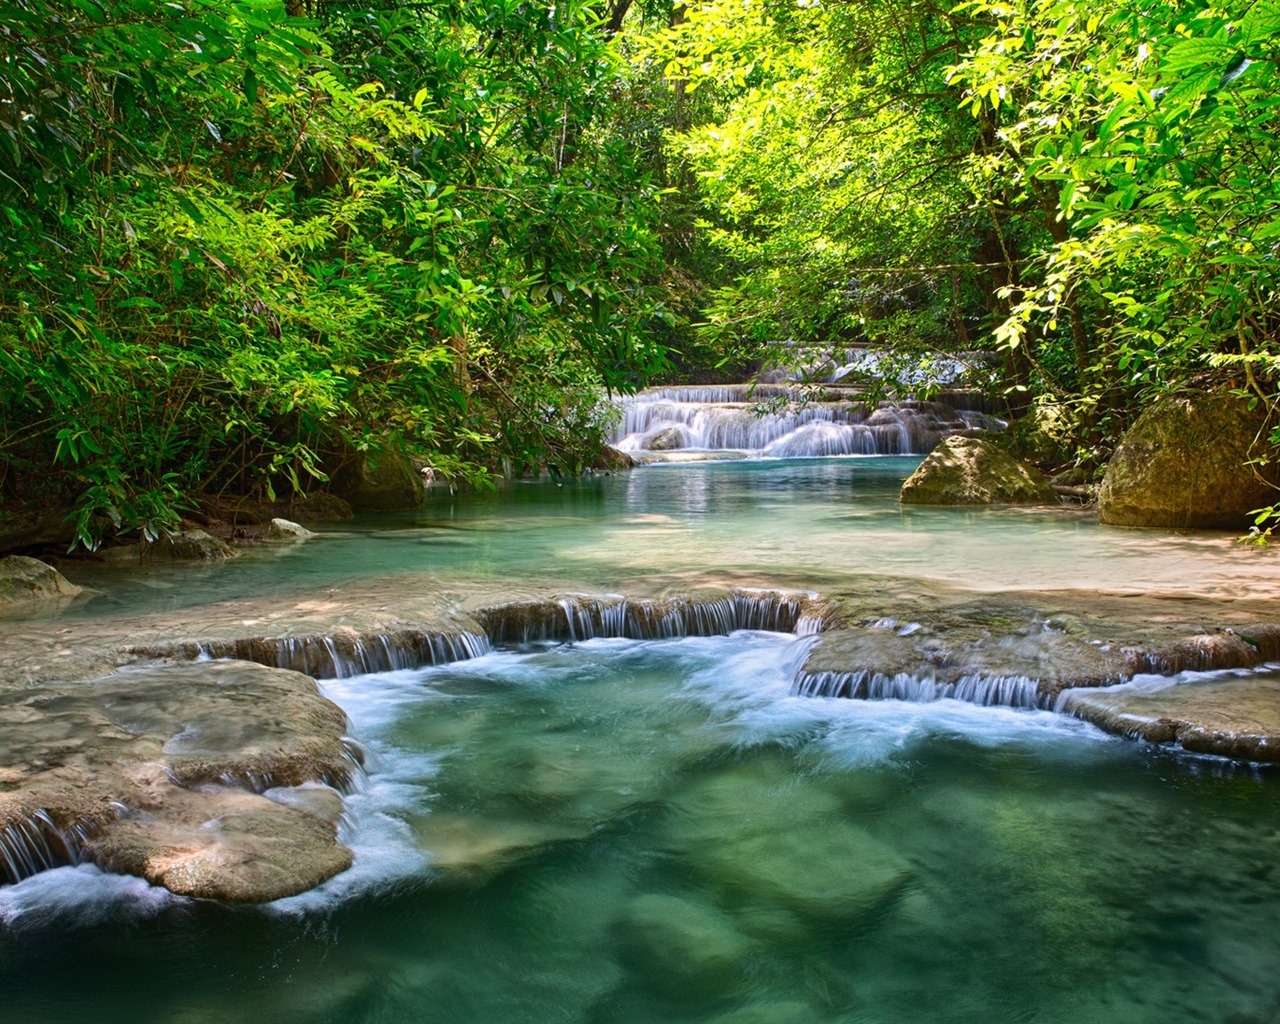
<box><xmin>67</xmin><ymin>458</ymin><xmax>1280</xmax><ymax>614</ymax></box>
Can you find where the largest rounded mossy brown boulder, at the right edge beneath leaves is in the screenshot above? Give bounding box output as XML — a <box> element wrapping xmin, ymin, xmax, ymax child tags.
<box><xmin>1098</xmin><ymin>392</ymin><xmax>1280</xmax><ymax>530</ymax></box>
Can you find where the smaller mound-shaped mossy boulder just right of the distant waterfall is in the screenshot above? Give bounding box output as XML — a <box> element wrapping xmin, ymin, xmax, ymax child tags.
<box><xmin>901</xmin><ymin>435</ymin><xmax>1059</xmax><ymax>504</ymax></box>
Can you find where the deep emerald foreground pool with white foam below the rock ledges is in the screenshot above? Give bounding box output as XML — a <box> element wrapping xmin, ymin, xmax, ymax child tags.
<box><xmin>0</xmin><ymin>632</ymin><xmax>1280</xmax><ymax>1024</ymax></box>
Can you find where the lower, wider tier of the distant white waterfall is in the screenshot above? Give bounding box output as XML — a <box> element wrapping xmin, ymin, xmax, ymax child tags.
<box><xmin>614</xmin><ymin>385</ymin><xmax>1005</xmax><ymax>458</ymax></box>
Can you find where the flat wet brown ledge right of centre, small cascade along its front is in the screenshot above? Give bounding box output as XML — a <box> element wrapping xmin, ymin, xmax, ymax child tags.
<box><xmin>797</xmin><ymin>582</ymin><xmax>1280</xmax><ymax>708</ymax></box>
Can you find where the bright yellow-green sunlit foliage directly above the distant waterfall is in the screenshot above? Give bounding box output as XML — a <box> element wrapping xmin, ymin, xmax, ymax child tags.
<box><xmin>650</xmin><ymin>3</ymin><xmax>992</xmax><ymax>389</ymax></box>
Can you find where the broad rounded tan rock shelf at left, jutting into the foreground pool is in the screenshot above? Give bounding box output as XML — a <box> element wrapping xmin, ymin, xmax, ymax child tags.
<box><xmin>0</xmin><ymin>662</ymin><xmax>356</xmax><ymax>902</ymax></box>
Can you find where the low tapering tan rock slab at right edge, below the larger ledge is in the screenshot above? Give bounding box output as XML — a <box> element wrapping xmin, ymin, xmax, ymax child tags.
<box><xmin>1057</xmin><ymin>672</ymin><xmax>1280</xmax><ymax>762</ymax></box>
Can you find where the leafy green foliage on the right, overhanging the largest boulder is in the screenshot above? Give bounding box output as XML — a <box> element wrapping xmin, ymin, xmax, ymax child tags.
<box><xmin>954</xmin><ymin>0</ymin><xmax>1280</xmax><ymax>499</ymax></box>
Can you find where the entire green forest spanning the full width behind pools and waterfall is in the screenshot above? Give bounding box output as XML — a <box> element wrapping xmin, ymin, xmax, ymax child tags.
<box><xmin>0</xmin><ymin>0</ymin><xmax>1280</xmax><ymax>547</ymax></box>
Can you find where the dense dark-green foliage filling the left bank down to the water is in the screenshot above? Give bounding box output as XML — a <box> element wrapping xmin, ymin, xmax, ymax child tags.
<box><xmin>0</xmin><ymin>0</ymin><xmax>664</xmax><ymax>545</ymax></box>
